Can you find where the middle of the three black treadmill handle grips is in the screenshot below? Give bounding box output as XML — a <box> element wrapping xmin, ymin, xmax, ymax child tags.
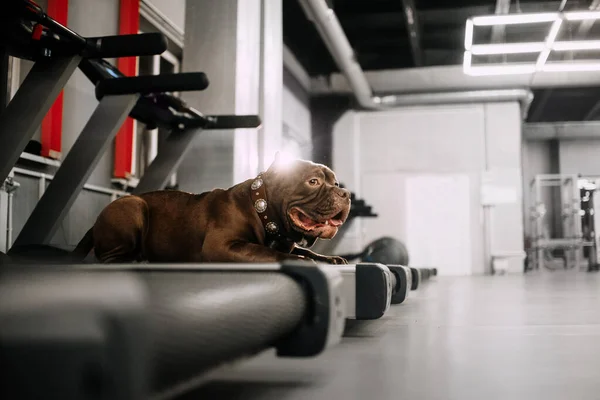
<box><xmin>96</xmin><ymin>72</ymin><xmax>209</xmax><ymax>99</ymax></box>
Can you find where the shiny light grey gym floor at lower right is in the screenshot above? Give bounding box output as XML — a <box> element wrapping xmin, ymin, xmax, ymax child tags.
<box><xmin>185</xmin><ymin>272</ymin><xmax>600</xmax><ymax>400</ymax></box>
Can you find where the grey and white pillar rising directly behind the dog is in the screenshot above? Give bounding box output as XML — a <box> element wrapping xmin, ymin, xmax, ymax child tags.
<box><xmin>179</xmin><ymin>0</ymin><xmax>283</xmax><ymax>192</ymax></box>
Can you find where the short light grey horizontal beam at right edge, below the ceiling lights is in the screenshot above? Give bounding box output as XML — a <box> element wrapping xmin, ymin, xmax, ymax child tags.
<box><xmin>523</xmin><ymin>122</ymin><xmax>600</xmax><ymax>140</ymax></box>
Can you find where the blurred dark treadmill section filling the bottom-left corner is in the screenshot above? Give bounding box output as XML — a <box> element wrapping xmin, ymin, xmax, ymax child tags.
<box><xmin>0</xmin><ymin>268</ymin><xmax>150</xmax><ymax>400</ymax></box>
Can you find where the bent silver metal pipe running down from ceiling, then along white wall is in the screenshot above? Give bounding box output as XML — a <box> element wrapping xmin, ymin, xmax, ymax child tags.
<box><xmin>299</xmin><ymin>0</ymin><xmax>533</xmax><ymax>116</ymax></box>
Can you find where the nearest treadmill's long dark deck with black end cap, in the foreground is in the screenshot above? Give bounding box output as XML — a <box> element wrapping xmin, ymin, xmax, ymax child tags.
<box><xmin>0</xmin><ymin>263</ymin><xmax>345</xmax><ymax>400</ymax></box>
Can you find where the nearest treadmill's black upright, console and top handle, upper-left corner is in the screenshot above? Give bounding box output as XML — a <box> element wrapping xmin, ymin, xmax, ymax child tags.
<box><xmin>0</xmin><ymin>0</ymin><xmax>167</xmax><ymax>182</ymax></box>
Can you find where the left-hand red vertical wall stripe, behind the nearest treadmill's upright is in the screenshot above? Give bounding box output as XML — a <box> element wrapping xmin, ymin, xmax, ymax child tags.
<box><xmin>41</xmin><ymin>0</ymin><xmax>69</xmax><ymax>159</ymax></box>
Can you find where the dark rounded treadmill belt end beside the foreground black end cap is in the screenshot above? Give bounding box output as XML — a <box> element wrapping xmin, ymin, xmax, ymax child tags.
<box><xmin>140</xmin><ymin>272</ymin><xmax>307</xmax><ymax>391</ymax></box>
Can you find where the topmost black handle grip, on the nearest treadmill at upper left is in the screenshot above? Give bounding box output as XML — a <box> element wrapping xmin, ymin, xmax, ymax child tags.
<box><xmin>85</xmin><ymin>32</ymin><xmax>167</xmax><ymax>58</ymax></box>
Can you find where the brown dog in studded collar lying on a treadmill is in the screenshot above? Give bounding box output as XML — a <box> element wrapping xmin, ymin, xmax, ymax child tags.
<box><xmin>75</xmin><ymin>157</ymin><xmax>350</xmax><ymax>264</ymax></box>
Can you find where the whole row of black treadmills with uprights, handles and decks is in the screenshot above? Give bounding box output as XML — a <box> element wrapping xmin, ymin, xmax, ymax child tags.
<box><xmin>0</xmin><ymin>0</ymin><xmax>437</xmax><ymax>400</ymax></box>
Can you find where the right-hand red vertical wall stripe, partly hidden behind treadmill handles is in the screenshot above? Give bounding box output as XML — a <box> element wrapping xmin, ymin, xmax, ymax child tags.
<box><xmin>114</xmin><ymin>0</ymin><xmax>140</xmax><ymax>178</ymax></box>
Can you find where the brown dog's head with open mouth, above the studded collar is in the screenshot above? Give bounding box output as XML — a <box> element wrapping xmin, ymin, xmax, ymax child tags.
<box><xmin>264</xmin><ymin>154</ymin><xmax>350</xmax><ymax>246</ymax></box>
